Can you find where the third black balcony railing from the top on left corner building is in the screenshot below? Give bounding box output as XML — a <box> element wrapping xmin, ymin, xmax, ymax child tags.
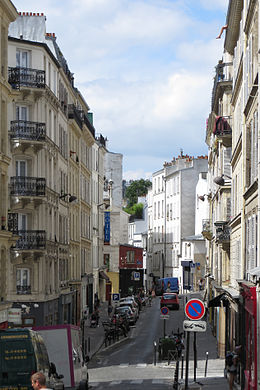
<box><xmin>10</xmin><ymin>176</ymin><xmax>46</xmax><ymax>196</ymax></box>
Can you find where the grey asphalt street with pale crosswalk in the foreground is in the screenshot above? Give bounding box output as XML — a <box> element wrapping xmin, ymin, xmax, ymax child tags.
<box><xmin>89</xmin><ymin>297</ymin><xmax>224</xmax><ymax>390</ymax></box>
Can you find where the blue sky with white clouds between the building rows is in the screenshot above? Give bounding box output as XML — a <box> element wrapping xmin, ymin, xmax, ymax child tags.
<box><xmin>13</xmin><ymin>0</ymin><xmax>228</xmax><ymax>180</ymax></box>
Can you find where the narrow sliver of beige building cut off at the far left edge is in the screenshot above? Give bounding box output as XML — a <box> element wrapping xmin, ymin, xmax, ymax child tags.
<box><xmin>0</xmin><ymin>0</ymin><xmax>18</xmax><ymax>328</ymax></box>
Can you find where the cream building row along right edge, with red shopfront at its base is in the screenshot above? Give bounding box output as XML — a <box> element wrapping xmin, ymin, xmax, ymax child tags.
<box><xmin>205</xmin><ymin>0</ymin><xmax>260</xmax><ymax>389</ymax></box>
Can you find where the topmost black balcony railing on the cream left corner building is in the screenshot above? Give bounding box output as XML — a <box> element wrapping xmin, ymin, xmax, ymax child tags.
<box><xmin>8</xmin><ymin>67</ymin><xmax>45</xmax><ymax>89</ymax></box>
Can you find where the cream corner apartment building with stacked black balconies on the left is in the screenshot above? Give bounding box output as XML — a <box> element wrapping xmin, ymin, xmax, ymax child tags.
<box><xmin>6</xmin><ymin>13</ymin><xmax>98</xmax><ymax>325</ymax></box>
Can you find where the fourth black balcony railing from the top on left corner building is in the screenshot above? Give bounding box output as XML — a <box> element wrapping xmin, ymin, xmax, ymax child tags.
<box><xmin>13</xmin><ymin>230</ymin><xmax>46</xmax><ymax>250</ymax></box>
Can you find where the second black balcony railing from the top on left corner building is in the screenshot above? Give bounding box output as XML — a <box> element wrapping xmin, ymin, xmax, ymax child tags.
<box><xmin>9</xmin><ymin>120</ymin><xmax>46</xmax><ymax>141</ymax></box>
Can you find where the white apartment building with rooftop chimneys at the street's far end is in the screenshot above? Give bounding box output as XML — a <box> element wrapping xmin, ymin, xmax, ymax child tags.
<box><xmin>147</xmin><ymin>154</ymin><xmax>208</xmax><ymax>289</ymax></box>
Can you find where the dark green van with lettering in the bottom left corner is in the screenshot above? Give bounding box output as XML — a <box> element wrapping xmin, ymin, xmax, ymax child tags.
<box><xmin>0</xmin><ymin>328</ymin><xmax>64</xmax><ymax>390</ymax></box>
